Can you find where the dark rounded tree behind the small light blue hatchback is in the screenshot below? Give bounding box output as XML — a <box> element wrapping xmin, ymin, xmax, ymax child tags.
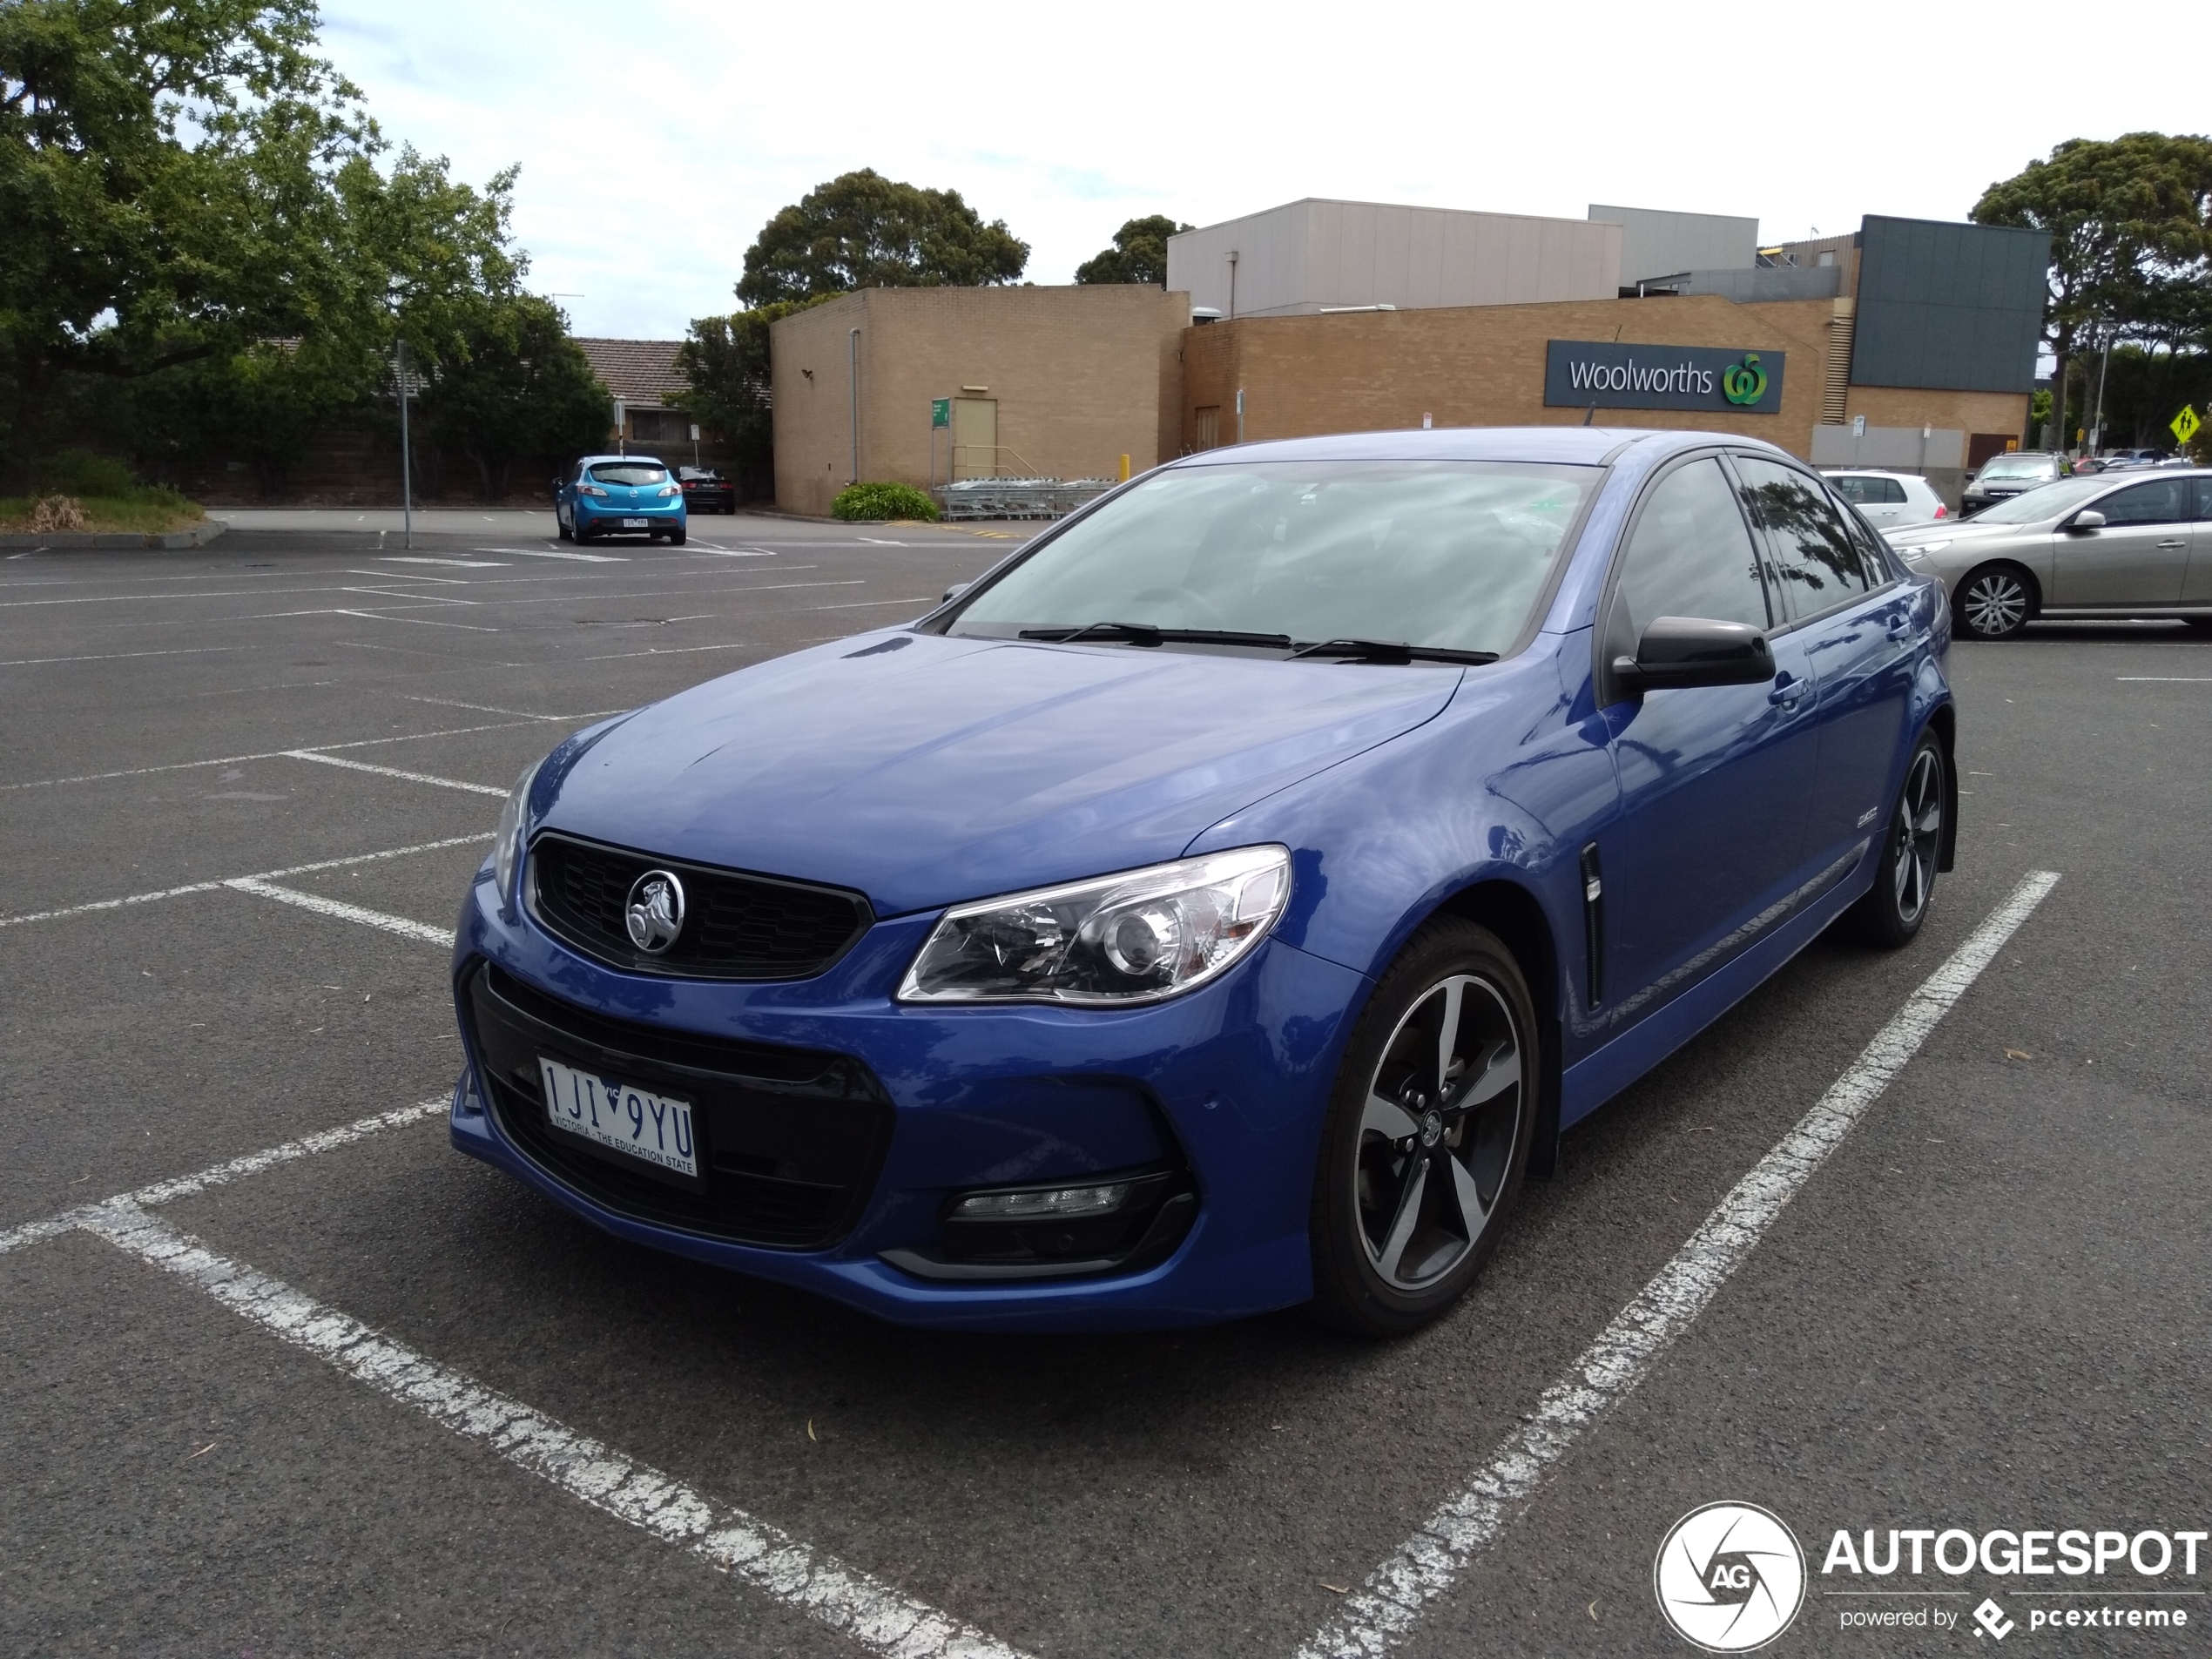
<box><xmin>422</xmin><ymin>294</ymin><xmax>610</xmax><ymax>500</ymax></box>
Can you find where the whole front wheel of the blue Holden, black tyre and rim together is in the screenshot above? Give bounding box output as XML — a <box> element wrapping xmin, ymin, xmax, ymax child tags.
<box><xmin>1310</xmin><ymin>918</ymin><xmax>1541</xmax><ymax>1336</ymax></box>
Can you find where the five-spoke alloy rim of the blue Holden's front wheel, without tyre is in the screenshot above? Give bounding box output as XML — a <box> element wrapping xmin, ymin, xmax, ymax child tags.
<box><xmin>1353</xmin><ymin>974</ymin><xmax>1528</xmax><ymax>1290</ymax></box>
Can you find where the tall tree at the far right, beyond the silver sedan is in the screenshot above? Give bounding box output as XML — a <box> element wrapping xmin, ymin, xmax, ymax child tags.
<box><xmin>1971</xmin><ymin>132</ymin><xmax>2212</xmax><ymax>447</ymax></box>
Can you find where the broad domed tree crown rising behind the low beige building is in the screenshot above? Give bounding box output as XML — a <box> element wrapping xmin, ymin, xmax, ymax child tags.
<box><xmin>737</xmin><ymin>168</ymin><xmax>1028</xmax><ymax>307</ymax></box>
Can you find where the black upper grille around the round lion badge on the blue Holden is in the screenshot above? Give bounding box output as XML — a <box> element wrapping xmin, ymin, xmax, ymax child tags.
<box><xmin>529</xmin><ymin>832</ymin><xmax>876</xmax><ymax>980</ymax></box>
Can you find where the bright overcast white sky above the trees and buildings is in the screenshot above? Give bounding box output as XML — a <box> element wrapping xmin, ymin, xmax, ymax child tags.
<box><xmin>323</xmin><ymin>0</ymin><xmax>2212</xmax><ymax>339</ymax></box>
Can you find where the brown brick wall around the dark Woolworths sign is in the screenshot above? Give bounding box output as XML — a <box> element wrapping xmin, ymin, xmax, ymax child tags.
<box><xmin>1181</xmin><ymin>294</ymin><xmax>2027</xmax><ymax>458</ymax></box>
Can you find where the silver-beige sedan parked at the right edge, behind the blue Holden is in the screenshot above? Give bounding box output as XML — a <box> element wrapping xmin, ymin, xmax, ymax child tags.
<box><xmin>1889</xmin><ymin>469</ymin><xmax>2212</xmax><ymax>639</ymax></box>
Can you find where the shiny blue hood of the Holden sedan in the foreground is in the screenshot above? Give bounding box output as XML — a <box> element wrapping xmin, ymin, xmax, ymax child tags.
<box><xmin>542</xmin><ymin>632</ymin><xmax>1462</xmax><ymax>916</ymax></box>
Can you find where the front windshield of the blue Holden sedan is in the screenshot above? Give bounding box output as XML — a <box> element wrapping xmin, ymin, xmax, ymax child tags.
<box><xmin>947</xmin><ymin>460</ymin><xmax>1602</xmax><ymax>652</ymax></box>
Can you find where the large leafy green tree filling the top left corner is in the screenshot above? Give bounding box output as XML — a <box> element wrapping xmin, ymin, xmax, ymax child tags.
<box><xmin>0</xmin><ymin>0</ymin><xmax>376</xmax><ymax>462</ymax></box>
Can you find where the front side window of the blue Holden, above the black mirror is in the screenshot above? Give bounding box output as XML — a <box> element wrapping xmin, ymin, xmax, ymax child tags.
<box><xmin>1606</xmin><ymin>458</ymin><xmax>1767</xmax><ymax>655</ymax></box>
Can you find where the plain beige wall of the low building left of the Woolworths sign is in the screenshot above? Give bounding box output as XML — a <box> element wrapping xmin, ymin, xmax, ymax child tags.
<box><xmin>770</xmin><ymin>283</ymin><xmax>1190</xmax><ymax>513</ymax></box>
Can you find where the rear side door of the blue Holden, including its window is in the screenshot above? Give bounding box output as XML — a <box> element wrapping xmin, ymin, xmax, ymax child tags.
<box><xmin>1732</xmin><ymin>454</ymin><xmax>1926</xmax><ymax>898</ymax></box>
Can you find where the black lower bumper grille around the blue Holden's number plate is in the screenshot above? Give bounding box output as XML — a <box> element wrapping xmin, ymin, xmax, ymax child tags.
<box><xmin>460</xmin><ymin>962</ymin><xmax>892</xmax><ymax>1250</ymax></box>
